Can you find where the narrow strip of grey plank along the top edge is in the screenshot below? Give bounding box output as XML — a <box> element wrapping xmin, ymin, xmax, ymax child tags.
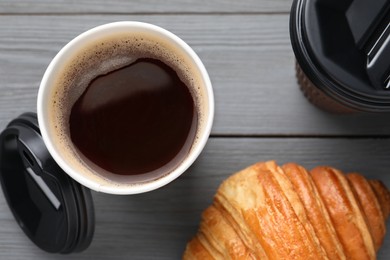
<box><xmin>0</xmin><ymin>0</ymin><xmax>292</xmax><ymax>14</ymax></box>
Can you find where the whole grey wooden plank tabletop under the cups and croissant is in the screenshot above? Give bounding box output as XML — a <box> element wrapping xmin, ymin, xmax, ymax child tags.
<box><xmin>0</xmin><ymin>0</ymin><xmax>390</xmax><ymax>259</ymax></box>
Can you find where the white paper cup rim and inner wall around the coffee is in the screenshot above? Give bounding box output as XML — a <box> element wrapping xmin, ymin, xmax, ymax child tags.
<box><xmin>37</xmin><ymin>21</ymin><xmax>214</xmax><ymax>194</ymax></box>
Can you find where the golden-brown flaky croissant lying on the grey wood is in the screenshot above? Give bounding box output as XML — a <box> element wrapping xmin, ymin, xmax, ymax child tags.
<box><xmin>183</xmin><ymin>161</ymin><xmax>390</xmax><ymax>259</ymax></box>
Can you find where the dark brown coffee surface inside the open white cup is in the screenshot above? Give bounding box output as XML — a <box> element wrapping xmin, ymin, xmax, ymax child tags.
<box><xmin>69</xmin><ymin>59</ymin><xmax>197</xmax><ymax>175</ymax></box>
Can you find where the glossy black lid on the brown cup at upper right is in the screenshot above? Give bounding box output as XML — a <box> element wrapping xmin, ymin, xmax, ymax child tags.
<box><xmin>290</xmin><ymin>0</ymin><xmax>390</xmax><ymax>112</ymax></box>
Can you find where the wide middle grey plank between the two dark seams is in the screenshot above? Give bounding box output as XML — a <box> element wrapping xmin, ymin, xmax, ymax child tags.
<box><xmin>0</xmin><ymin>14</ymin><xmax>390</xmax><ymax>136</ymax></box>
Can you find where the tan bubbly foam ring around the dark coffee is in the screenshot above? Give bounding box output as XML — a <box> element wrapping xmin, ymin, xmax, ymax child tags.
<box><xmin>49</xmin><ymin>33</ymin><xmax>208</xmax><ymax>186</ymax></box>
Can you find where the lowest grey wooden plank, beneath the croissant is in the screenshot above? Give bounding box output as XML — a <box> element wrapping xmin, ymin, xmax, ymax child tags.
<box><xmin>0</xmin><ymin>138</ymin><xmax>390</xmax><ymax>260</ymax></box>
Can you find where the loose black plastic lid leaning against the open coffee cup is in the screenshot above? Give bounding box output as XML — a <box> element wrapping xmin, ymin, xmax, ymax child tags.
<box><xmin>0</xmin><ymin>113</ymin><xmax>95</xmax><ymax>254</ymax></box>
